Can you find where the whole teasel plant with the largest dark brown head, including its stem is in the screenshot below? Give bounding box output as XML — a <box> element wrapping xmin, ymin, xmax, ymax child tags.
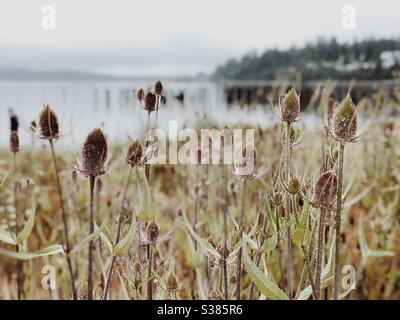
<box><xmin>76</xmin><ymin>128</ymin><xmax>108</xmax><ymax>300</ymax></box>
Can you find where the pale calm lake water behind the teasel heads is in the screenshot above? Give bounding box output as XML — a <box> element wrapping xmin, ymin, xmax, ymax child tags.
<box><xmin>0</xmin><ymin>81</ymin><xmax>316</xmax><ymax>149</ymax></box>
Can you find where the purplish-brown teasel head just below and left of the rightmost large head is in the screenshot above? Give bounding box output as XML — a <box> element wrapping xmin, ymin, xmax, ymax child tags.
<box><xmin>311</xmin><ymin>171</ymin><xmax>337</xmax><ymax>210</ymax></box>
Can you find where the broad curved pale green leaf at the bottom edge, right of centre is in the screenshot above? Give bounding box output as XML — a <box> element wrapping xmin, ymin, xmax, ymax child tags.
<box><xmin>243</xmin><ymin>246</ymin><xmax>289</xmax><ymax>300</ymax></box>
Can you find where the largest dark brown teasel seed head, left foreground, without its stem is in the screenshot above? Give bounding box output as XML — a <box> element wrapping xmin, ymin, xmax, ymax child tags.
<box><xmin>81</xmin><ymin>129</ymin><xmax>108</xmax><ymax>177</ymax></box>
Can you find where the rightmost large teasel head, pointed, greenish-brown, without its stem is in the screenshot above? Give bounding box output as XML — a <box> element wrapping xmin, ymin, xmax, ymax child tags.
<box><xmin>332</xmin><ymin>94</ymin><xmax>357</xmax><ymax>142</ymax></box>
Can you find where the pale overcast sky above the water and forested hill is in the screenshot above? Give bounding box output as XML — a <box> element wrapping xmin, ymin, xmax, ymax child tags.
<box><xmin>0</xmin><ymin>0</ymin><xmax>400</xmax><ymax>76</ymax></box>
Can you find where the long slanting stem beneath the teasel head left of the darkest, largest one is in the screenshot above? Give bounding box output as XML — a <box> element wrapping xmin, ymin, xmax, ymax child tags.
<box><xmin>49</xmin><ymin>139</ymin><xmax>77</xmax><ymax>300</ymax></box>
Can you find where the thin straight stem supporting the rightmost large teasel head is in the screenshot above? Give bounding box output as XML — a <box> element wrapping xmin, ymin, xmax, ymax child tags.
<box><xmin>333</xmin><ymin>142</ymin><xmax>345</xmax><ymax>300</ymax></box>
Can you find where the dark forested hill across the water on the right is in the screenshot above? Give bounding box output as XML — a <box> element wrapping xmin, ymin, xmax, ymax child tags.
<box><xmin>213</xmin><ymin>38</ymin><xmax>400</xmax><ymax>80</ymax></box>
